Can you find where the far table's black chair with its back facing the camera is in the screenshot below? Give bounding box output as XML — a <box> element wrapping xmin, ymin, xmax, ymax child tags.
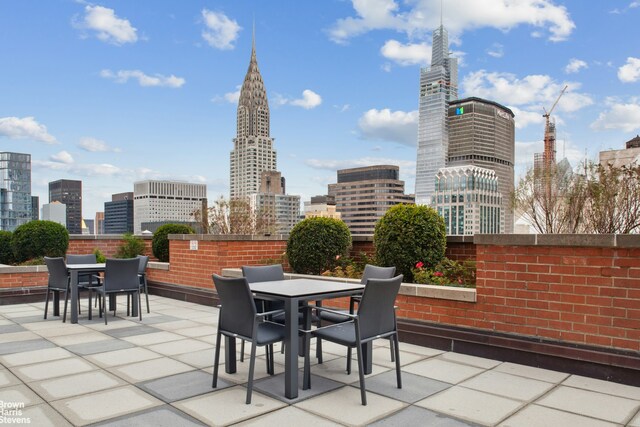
<box><xmin>93</xmin><ymin>258</ymin><xmax>142</xmax><ymax>325</ymax></box>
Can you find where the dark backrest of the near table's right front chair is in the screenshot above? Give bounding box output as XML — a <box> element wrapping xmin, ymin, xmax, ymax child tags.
<box><xmin>358</xmin><ymin>274</ymin><xmax>402</xmax><ymax>339</ymax></box>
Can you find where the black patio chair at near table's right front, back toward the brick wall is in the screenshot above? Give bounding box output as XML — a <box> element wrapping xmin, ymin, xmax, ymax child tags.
<box><xmin>303</xmin><ymin>275</ymin><xmax>402</xmax><ymax>405</ymax></box>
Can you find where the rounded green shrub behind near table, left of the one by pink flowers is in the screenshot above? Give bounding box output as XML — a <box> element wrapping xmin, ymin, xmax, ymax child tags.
<box><xmin>287</xmin><ymin>217</ymin><xmax>351</xmax><ymax>274</ymax></box>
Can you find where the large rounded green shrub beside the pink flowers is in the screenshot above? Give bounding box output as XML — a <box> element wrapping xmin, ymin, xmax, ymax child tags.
<box><xmin>373</xmin><ymin>205</ymin><xmax>447</xmax><ymax>281</ymax></box>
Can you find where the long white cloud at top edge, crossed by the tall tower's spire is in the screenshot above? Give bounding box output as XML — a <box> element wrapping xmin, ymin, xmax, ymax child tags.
<box><xmin>328</xmin><ymin>0</ymin><xmax>575</xmax><ymax>43</ymax></box>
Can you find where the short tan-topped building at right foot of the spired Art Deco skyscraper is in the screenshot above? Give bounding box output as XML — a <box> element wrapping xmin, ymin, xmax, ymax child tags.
<box><xmin>249</xmin><ymin>171</ymin><xmax>300</xmax><ymax>234</ymax></box>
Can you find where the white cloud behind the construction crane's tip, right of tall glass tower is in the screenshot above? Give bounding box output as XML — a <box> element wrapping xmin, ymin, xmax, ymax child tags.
<box><xmin>461</xmin><ymin>70</ymin><xmax>593</xmax><ymax>113</ymax></box>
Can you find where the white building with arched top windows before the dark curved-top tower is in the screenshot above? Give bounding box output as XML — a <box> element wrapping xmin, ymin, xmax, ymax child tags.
<box><xmin>434</xmin><ymin>165</ymin><xmax>505</xmax><ymax>236</ymax></box>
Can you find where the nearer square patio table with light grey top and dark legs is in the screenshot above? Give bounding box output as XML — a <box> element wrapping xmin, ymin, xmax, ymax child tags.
<box><xmin>234</xmin><ymin>279</ymin><xmax>371</xmax><ymax>399</ymax></box>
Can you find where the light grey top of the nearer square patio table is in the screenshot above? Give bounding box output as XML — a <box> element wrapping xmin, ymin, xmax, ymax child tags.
<box><xmin>249</xmin><ymin>279</ymin><xmax>364</xmax><ymax>298</ymax></box>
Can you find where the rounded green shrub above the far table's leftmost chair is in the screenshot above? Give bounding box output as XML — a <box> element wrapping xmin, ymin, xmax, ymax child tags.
<box><xmin>11</xmin><ymin>221</ymin><xmax>69</xmax><ymax>263</ymax></box>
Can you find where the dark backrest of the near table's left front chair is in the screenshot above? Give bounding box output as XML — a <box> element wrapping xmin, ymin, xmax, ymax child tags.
<box><xmin>213</xmin><ymin>274</ymin><xmax>256</xmax><ymax>338</ymax></box>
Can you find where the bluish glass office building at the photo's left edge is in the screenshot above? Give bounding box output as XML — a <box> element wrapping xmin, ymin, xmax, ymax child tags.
<box><xmin>0</xmin><ymin>152</ymin><xmax>33</xmax><ymax>231</ymax></box>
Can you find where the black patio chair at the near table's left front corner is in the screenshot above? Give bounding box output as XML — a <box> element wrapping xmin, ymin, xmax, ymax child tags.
<box><xmin>211</xmin><ymin>274</ymin><xmax>285</xmax><ymax>404</ymax></box>
